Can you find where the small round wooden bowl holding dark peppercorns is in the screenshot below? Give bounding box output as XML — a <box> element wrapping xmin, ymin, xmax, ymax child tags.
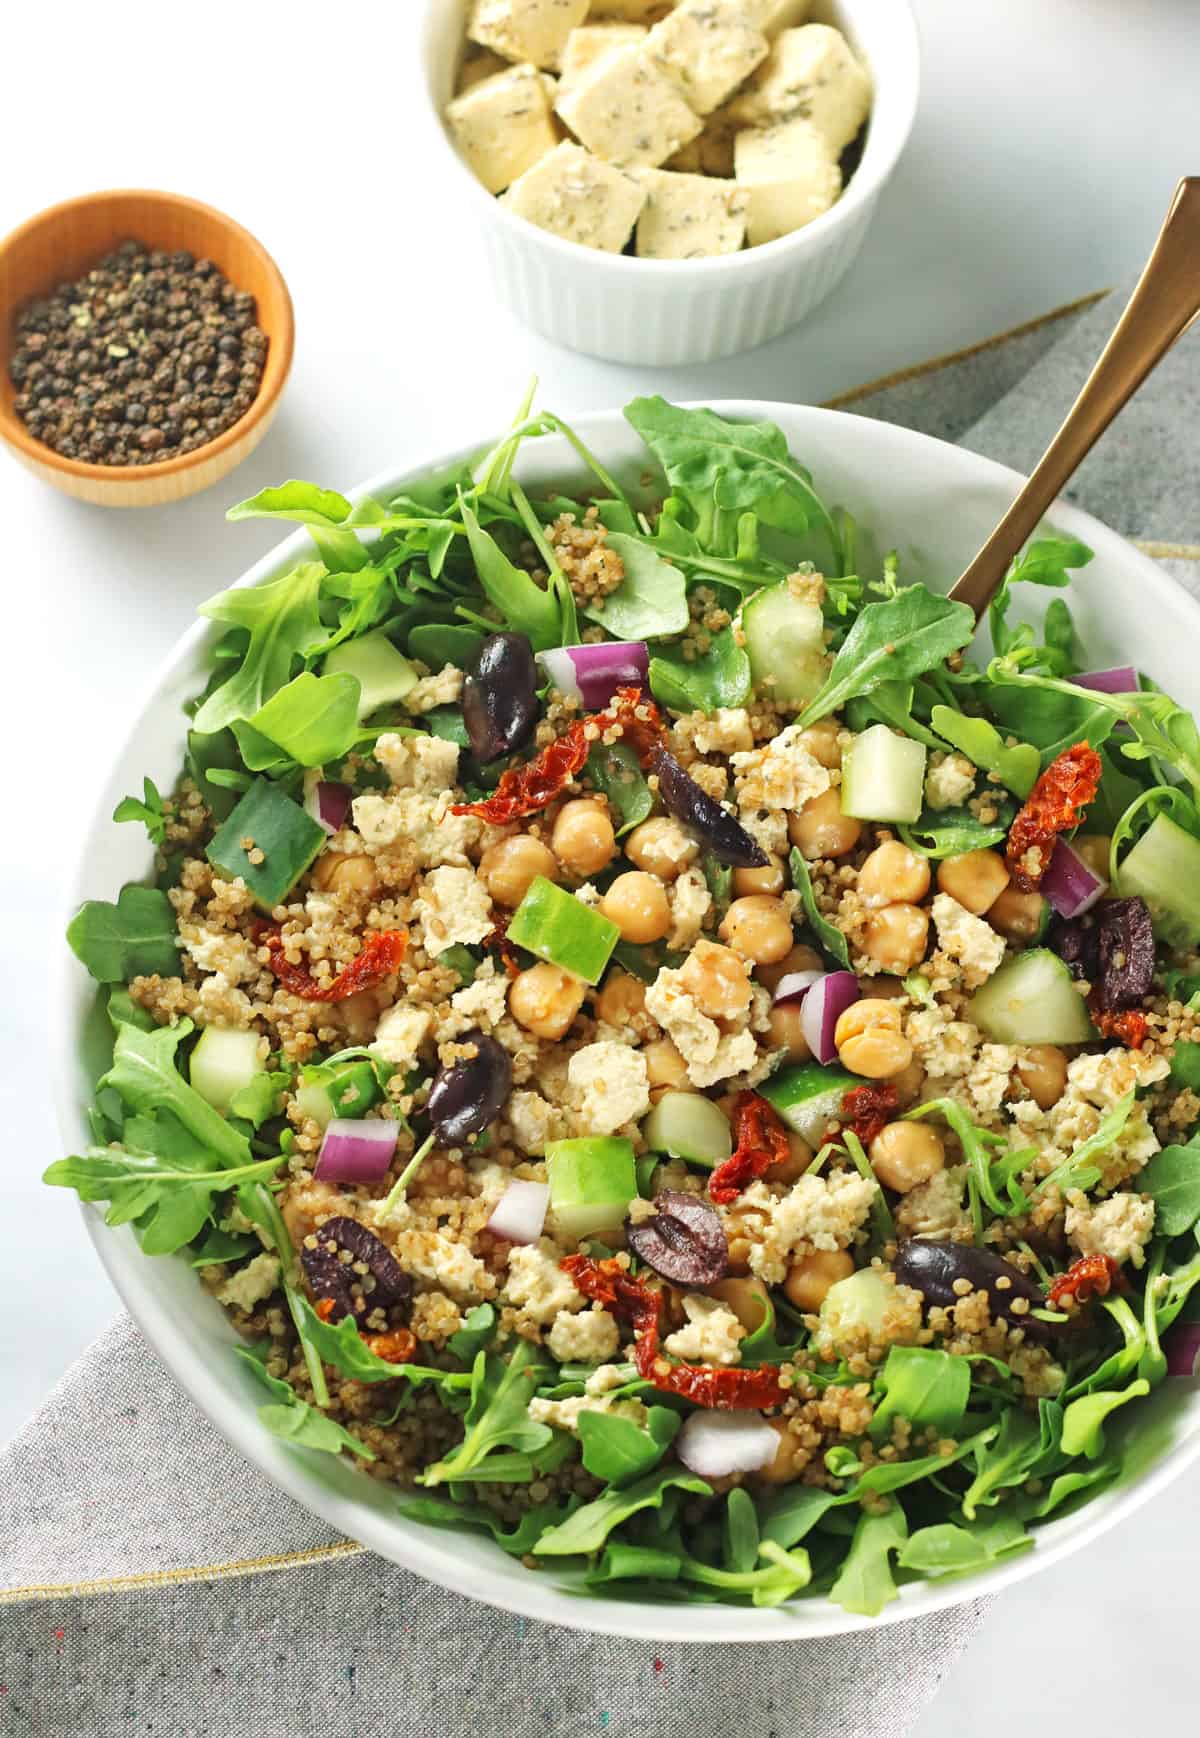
<box><xmin>0</xmin><ymin>191</ymin><xmax>296</xmax><ymax>507</ymax></box>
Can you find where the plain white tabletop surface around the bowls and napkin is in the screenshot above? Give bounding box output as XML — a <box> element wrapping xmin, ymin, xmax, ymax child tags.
<box><xmin>0</xmin><ymin>0</ymin><xmax>1200</xmax><ymax>1717</ymax></box>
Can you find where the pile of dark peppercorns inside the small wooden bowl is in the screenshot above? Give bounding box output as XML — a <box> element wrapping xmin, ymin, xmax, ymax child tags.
<box><xmin>9</xmin><ymin>242</ymin><xmax>266</xmax><ymax>464</ymax></box>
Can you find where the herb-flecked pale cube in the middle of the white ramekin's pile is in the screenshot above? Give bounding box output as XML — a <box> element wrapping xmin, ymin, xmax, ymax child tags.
<box><xmin>555</xmin><ymin>38</ymin><xmax>703</xmax><ymax>167</ymax></box>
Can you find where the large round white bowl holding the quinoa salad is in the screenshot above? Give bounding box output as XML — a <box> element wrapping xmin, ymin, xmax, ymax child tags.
<box><xmin>56</xmin><ymin>403</ymin><xmax>1200</xmax><ymax>1641</ymax></box>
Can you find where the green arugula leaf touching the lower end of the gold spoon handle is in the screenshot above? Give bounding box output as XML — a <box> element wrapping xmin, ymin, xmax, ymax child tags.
<box><xmin>798</xmin><ymin>586</ymin><xmax>976</xmax><ymax>726</ymax></box>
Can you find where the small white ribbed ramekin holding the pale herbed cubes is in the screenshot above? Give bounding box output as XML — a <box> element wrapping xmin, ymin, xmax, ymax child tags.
<box><xmin>421</xmin><ymin>0</ymin><xmax>920</xmax><ymax>367</ymax></box>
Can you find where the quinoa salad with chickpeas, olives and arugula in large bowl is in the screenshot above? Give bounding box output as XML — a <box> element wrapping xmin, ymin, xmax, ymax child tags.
<box><xmin>47</xmin><ymin>398</ymin><xmax>1200</xmax><ymax>1615</ymax></box>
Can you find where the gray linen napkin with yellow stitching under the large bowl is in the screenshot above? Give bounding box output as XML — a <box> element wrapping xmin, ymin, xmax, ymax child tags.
<box><xmin>0</xmin><ymin>285</ymin><xmax>1200</xmax><ymax>1738</ymax></box>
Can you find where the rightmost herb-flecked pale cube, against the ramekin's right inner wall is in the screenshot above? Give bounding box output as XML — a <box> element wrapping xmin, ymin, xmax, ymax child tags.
<box><xmin>730</xmin><ymin>24</ymin><xmax>871</xmax><ymax>156</ymax></box>
